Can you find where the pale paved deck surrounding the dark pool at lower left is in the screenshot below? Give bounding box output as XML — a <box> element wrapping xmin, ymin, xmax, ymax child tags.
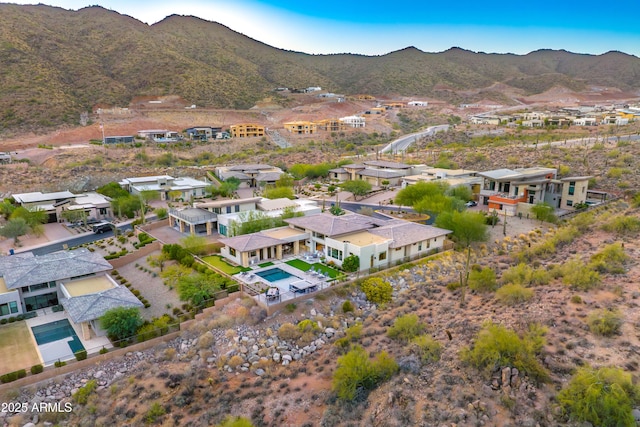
<box><xmin>25</xmin><ymin>311</ymin><xmax>112</xmax><ymax>365</ymax></box>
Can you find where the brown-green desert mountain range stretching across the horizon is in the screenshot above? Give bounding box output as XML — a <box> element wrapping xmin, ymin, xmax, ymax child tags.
<box><xmin>0</xmin><ymin>4</ymin><xmax>640</xmax><ymax>133</ymax></box>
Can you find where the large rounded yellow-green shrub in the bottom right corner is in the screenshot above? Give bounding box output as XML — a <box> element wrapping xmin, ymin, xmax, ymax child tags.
<box><xmin>557</xmin><ymin>366</ymin><xmax>640</xmax><ymax>427</ymax></box>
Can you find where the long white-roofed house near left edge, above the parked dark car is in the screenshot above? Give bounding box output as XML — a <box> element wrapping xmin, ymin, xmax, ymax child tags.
<box><xmin>12</xmin><ymin>191</ymin><xmax>113</xmax><ymax>222</ymax></box>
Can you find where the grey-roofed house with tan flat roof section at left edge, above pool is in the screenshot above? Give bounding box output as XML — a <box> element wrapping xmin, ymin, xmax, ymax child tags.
<box><xmin>0</xmin><ymin>248</ymin><xmax>143</xmax><ymax>339</ymax></box>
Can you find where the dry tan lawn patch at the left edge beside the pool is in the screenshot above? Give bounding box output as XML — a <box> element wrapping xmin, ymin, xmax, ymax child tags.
<box><xmin>0</xmin><ymin>321</ymin><xmax>41</xmax><ymax>374</ymax></box>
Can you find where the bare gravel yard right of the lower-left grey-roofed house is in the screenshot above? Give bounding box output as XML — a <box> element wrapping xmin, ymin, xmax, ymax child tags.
<box><xmin>118</xmin><ymin>251</ymin><xmax>182</xmax><ymax>320</ymax></box>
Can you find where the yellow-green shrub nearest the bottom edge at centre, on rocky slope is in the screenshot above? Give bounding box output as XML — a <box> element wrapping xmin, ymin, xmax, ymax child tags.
<box><xmin>332</xmin><ymin>346</ymin><xmax>398</xmax><ymax>401</ymax></box>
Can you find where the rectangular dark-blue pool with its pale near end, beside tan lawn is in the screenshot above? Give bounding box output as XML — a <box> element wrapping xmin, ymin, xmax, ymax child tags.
<box><xmin>31</xmin><ymin>319</ymin><xmax>85</xmax><ymax>364</ymax></box>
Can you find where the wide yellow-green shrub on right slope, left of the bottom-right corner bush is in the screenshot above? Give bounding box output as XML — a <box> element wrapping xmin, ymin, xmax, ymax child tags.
<box><xmin>460</xmin><ymin>322</ymin><xmax>549</xmax><ymax>382</ymax></box>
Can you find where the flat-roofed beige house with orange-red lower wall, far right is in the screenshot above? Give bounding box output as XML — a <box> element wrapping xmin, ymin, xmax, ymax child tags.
<box><xmin>478</xmin><ymin>167</ymin><xmax>591</xmax><ymax>216</ymax></box>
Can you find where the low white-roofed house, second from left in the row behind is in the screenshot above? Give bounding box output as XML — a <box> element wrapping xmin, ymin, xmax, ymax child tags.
<box><xmin>119</xmin><ymin>175</ymin><xmax>210</xmax><ymax>200</ymax></box>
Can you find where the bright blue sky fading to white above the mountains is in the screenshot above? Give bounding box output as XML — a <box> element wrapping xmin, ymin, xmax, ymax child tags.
<box><xmin>10</xmin><ymin>0</ymin><xmax>640</xmax><ymax>57</ymax></box>
